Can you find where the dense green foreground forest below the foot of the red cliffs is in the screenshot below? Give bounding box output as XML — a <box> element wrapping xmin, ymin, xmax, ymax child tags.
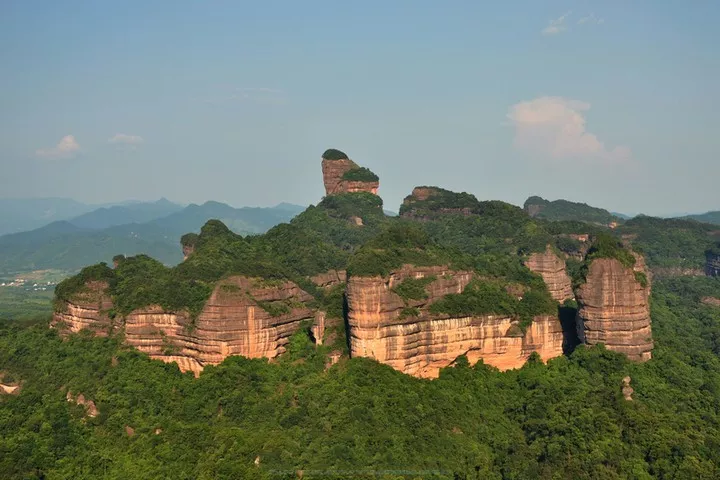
<box><xmin>0</xmin><ymin>278</ymin><xmax>720</xmax><ymax>479</ymax></box>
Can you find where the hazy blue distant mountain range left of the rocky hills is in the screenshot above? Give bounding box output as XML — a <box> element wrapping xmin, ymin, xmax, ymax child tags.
<box><xmin>0</xmin><ymin>199</ymin><xmax>305</xmax><ymax>272</ymax></box>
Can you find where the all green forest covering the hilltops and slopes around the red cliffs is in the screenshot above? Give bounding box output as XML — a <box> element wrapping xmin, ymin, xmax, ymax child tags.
<box><xmin>0</xmin><ymin>192</ymin><xmax>720</xmax><ymax>480</ymax></box>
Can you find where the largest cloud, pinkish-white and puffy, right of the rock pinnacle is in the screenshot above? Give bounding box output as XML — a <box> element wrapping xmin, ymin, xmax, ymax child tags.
<box><xmin>507</xmin><ymin>97</ymin><xmax>632</xmax><ymax>163</ymax></box>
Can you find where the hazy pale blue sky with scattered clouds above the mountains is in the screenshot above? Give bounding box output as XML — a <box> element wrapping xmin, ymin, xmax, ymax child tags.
<box><xmin>0</xmin><ymin>0</ymin><xmax>720</xmax><ymax>215</ymax></box>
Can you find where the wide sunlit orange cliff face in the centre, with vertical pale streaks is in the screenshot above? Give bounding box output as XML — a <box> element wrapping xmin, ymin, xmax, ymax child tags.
<box><xmin>347</xmin><ymin>266</ymin><xmax>563</xmax><ymax>378</ymax></box>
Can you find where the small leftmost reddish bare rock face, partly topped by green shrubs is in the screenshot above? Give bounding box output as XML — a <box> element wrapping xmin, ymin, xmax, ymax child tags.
<box><xmin>50</xmin><ymin>282</ymin><xmax>117</xmax><ymax>336</ymax></box>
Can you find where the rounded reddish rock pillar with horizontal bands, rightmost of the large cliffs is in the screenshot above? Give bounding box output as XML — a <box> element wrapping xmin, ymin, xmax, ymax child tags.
<box><xmin>575</xmin><ymin>258</ymin><xmax>653</xmax><ymax>361</ymax></box>
